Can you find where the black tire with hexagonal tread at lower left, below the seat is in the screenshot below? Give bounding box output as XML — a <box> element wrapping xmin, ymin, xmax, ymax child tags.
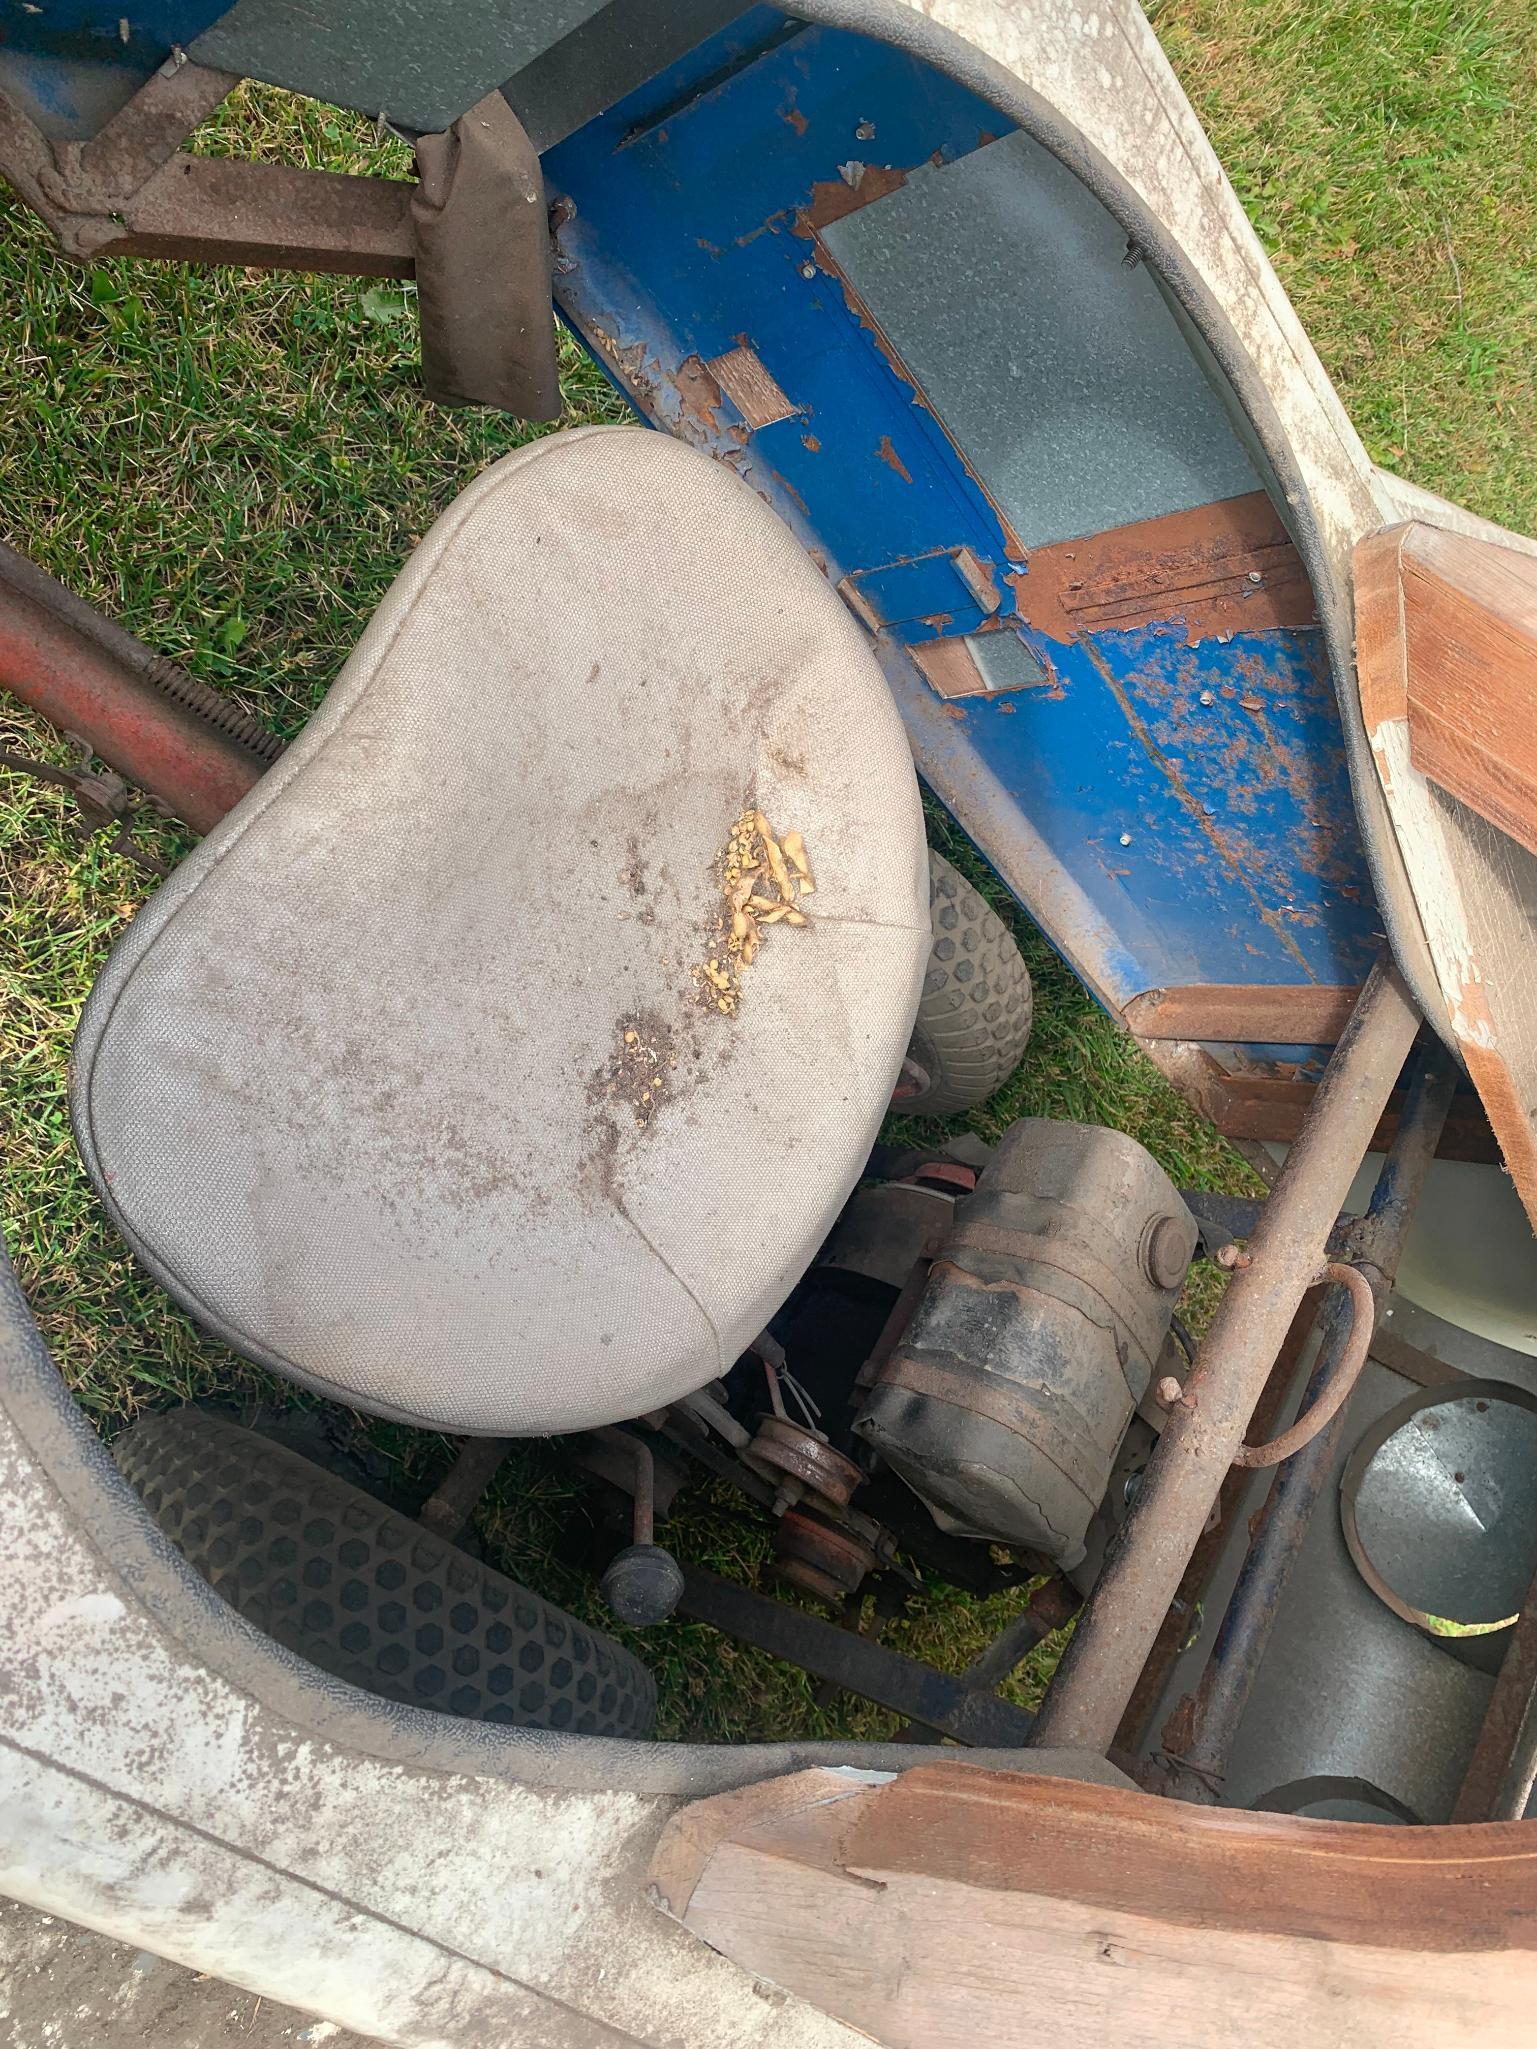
<box><xmin>113</xmin><ymin>1408</ymin><xmax>656</xmax><ymax>1736</ymax></box>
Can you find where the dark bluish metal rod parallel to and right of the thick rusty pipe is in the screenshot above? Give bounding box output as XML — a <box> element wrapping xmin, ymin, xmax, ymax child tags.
<box><xmin>1164</xmin><ymin>1039</ymin><xmax>1457</xmax><ymax>1803</ymax></box>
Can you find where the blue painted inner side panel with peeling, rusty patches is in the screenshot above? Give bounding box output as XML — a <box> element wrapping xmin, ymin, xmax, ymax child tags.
<box><xmin>545</xmin><ymin>8</ymin><xmax>1379</xmax><ymax>1004</ymax></box>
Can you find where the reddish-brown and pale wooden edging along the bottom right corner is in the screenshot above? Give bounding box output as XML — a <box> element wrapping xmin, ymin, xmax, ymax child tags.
<box><xmin>664</xmin><ymin>1764</ymin><xmax>1537</xmax><ymax>2049</ymax></box>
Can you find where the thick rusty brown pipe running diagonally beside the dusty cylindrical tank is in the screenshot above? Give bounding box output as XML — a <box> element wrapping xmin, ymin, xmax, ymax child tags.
<box><xmin>1031</xmin><ymin>963</ymin><xmax>1420</xmax><ymax>1756</ymax></box>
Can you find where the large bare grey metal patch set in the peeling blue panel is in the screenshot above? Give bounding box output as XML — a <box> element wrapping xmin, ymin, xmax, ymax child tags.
<box><xmin>822</xmin><ymin>133</ymin><xmax>1260</xmax><ymax>547</ymax></box>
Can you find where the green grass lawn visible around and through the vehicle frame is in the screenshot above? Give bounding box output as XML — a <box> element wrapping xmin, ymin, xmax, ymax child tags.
<box><xmin>0</xmin><ymin>0</ymin><xmax>1537</xmax><ymax>1738</ymax></box>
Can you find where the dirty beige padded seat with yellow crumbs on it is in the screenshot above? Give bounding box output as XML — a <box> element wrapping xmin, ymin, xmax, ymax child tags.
<box><xmin>72</xmin><ymin>428</ymin><xmax>930</xmax><ymax>1434</ymax></box>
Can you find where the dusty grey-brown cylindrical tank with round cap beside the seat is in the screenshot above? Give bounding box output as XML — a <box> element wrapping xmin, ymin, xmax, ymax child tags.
<box><xmin>855</xmin><ymin>1117</ymin><xmax>1197</xmax><ymax>1567</ymax></box>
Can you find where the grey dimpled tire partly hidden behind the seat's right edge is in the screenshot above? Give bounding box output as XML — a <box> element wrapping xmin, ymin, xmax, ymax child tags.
<box><xmin>909</xmin><ymin>846</ymin><xmax>1031</xmax><ymax>1117</ymax></box>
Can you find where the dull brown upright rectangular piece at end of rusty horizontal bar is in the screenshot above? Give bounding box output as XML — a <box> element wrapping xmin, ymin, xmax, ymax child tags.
<box><xmin>412</xmin><ymin>92</ymin><xmax>562</xmax><ymax>420</ymax></box>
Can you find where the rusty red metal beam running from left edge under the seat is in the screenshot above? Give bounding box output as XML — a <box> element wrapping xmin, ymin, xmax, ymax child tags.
<box><xmin>0</xmin><ymin>549</ymin><xmax>281</xmax><ymax>832</ymax></box>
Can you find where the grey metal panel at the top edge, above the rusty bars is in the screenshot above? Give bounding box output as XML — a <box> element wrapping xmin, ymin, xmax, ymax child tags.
<box><xmin>189</xmin><ymin>0</ymin><xmax>618</xmax><ymax>131</ymax></box>
